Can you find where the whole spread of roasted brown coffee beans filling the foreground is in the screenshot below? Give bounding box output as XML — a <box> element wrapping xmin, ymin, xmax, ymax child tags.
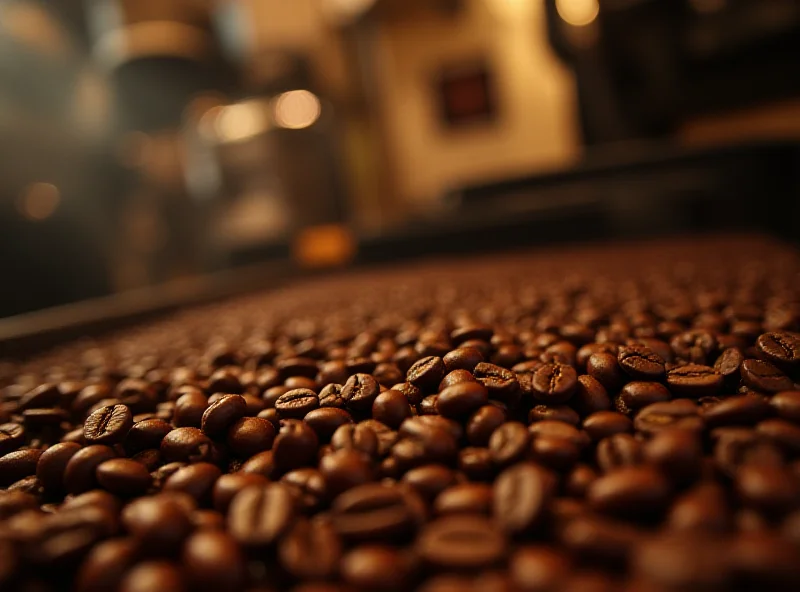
<box><xmin>0</xmin><ymin>237</ymin><xmax>800</xmax><ymax>592</ymax></box>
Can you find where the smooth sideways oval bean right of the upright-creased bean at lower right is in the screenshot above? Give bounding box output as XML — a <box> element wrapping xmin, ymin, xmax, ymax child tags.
<box><xmin>586</xmin><ymin>466</ymin><xmax>670</xmax><ymax>518</ymax></box>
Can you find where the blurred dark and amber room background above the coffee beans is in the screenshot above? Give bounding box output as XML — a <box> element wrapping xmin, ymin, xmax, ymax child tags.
<box><xmin>0</xmin><ymin>0</ymin><xmax>800</xmax><ymax>317</ymax></box>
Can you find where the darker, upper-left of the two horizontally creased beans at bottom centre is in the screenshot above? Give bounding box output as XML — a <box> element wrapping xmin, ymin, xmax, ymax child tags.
<box><xmin>331</xmin><ymin>483</ymin><xmax>422</xmax><ymax>541</ymax></box>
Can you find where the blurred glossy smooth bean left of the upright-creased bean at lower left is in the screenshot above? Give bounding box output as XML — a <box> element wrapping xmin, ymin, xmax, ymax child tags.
<box><xmin>122</xmin><ymin>494</ymin><xmax>192</xmax><ymax>554</ymax></box>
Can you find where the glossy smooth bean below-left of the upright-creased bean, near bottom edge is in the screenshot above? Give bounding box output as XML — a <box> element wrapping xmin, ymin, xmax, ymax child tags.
<box><xmin>182</xmin><ymin>530</ymin><xmax>247</xmax><ymax>591</ymax></box>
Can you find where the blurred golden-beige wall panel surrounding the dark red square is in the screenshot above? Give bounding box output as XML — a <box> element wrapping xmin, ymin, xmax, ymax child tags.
<box><xmin>377</xmin><ymin>0</ymin><xmax>578</xmax><ymax>205</ymax></box>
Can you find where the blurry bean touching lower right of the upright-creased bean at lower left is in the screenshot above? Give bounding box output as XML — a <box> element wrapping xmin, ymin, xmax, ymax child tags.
<box><xmin>278</xmin><ymin>519</ymin><xmax>342</xmax><ymax>580</ymax></box>
